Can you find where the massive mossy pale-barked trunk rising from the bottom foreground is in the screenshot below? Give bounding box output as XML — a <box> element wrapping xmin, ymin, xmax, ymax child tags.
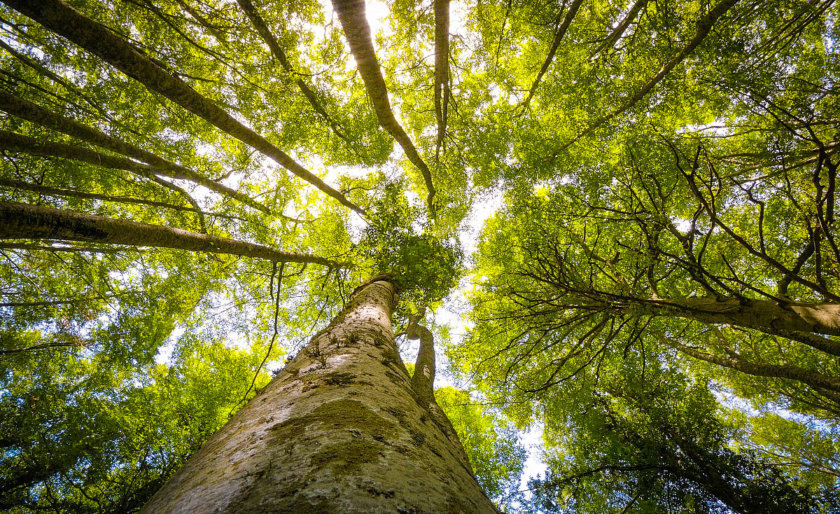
<box><xmin>142</xmin><ymin>279</ymin><xmax>495</xmax><ymax>513</ymax></box>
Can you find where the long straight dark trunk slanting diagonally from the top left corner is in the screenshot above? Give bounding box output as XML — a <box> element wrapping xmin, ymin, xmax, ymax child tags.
<box><xmin>4</xmin><ymin>0</ymin><xmax>364</xmax><ymax>214</ymax></box>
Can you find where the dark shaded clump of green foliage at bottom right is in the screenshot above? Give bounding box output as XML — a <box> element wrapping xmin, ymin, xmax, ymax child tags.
<box><xmin>531</xmin><ymin>370</ymin><xmax>837</xmax><ymax>513</ymax></box>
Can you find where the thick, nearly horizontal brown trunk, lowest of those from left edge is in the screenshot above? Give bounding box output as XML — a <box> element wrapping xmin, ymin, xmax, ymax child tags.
<box><xmin>0</xmin><ymin>202</ymin><xmax>346</xmax><ymax>267</ymax></box>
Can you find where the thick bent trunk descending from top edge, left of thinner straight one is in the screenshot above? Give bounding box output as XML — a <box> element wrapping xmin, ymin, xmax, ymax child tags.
<box><xmin>332</xmin><ymin>0</ymin><xmax>435</xmax><ymax>215</ymax></box>
